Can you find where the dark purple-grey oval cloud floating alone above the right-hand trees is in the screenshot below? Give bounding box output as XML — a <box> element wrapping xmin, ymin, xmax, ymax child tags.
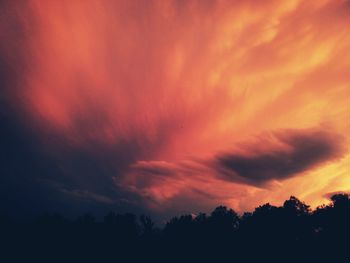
<box><xmin>215</xmin><ymin>130</ymin><xmax>344</xmax><ymax>185</ymax></box>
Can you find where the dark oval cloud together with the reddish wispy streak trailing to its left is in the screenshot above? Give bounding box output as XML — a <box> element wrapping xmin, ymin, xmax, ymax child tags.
<box><xmin>122</xmin><ymin>128</ymin><xmax>345</xmax><ymax>208</ymax></box>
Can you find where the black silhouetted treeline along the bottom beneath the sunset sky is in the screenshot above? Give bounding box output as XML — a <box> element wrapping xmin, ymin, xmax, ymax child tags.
<box><xmin>0</xmin><ymin>194</ymin><xmax>350</xmax><ymax>262</ymax></box>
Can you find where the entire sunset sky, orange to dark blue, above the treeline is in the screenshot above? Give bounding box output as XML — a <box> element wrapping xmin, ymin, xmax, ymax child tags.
<box><xmin>0</xmin><ymin>0</ymin><xmax>350</xmax><ymax>221</ymax></box>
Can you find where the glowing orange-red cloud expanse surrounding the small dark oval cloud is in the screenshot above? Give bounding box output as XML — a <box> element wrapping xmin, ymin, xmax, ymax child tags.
<box><xmin>4</xmin><ymin>0</ymin><xmax>350</xmax><ymax>216</ymax></box>
